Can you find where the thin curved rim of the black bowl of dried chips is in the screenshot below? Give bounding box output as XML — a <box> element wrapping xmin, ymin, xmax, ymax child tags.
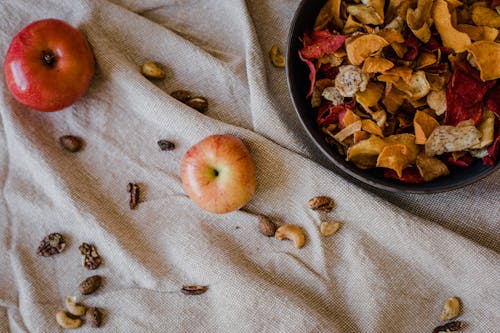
<box><xmin>285</xmin><ymin>0</ymin><xmax>500</xmax><ymax>194</ymax></box>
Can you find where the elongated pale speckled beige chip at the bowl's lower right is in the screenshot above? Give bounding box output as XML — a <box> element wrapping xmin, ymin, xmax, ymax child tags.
<box><xmin>425</xmin><ymin>125</ymin><xmax>481</xmax><ymax>156</ymax></box>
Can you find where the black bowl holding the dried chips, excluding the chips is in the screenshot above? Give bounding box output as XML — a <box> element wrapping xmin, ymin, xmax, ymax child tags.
<box><xmin>286</xmin><ymin>0</ymin><xmax>500</xmax><ymax>193</ymax></box>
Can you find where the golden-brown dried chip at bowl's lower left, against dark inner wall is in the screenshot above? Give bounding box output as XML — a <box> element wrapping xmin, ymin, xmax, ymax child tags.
<box><xmin>346</xmin><ymin>135</ymin><xmax>386</xmax><ymax>169</ymax></box>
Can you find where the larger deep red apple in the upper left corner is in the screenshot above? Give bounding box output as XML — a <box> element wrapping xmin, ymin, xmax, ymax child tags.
<box><xmin>4</xmin><ymin>19</ymin><xmax>95</xmax><ymax>112</ymax></box>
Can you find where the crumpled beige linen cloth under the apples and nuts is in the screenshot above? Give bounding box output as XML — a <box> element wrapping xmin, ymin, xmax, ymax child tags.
<box><xmin>0</xmin><ymin>0</ymin><xmax>500</xmax><ymax>333</ymax></box>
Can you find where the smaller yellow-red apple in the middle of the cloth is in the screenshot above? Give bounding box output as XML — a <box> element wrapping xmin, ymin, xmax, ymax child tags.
<box><xmin>181</xmin><ymin>134</ymin><xmax>255</xmax><ymax>214</ymax></box>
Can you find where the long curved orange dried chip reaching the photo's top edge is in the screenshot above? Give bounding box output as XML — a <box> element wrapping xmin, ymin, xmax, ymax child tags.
<box><xmin>432</xmin><ymin>0</ymin><xmax>471</xmax><ymax>52</ymax></box>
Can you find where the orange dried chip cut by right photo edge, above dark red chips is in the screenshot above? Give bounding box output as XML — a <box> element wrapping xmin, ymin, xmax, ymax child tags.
<box><xmin>468</xmin><ymin>41</ymin><xmax>500</xmax><ymax>81</ymax></box>
